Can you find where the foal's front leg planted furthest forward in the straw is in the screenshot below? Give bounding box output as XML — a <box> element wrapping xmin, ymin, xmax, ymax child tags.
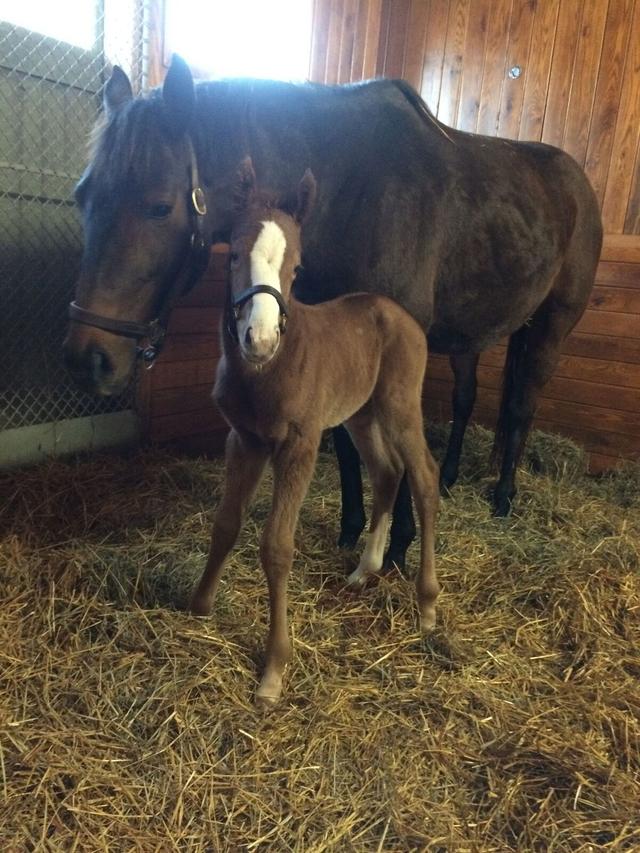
<box><xmin>256</xmin><ymin>434</ymin><xmax>320</xmax><ymax>705</ymax></box>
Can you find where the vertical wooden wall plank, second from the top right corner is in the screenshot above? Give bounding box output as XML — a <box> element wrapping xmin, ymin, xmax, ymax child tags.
<box><xmin>585</xmin><ymin>0</ymin><xmax>634</xmax><ymax>204</ymax></box>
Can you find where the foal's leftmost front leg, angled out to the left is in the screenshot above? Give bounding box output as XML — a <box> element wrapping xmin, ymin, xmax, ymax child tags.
<box><xmin>191</xmin><ymin>429</ymin><xmax>269</xmax><ymax>616</ymax></box>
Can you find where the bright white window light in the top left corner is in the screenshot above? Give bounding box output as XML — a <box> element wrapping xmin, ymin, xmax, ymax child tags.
<box><xmin>0</xmin><ymin>0</ymin><xmax>96</xmax><ymax>50</ymax></box>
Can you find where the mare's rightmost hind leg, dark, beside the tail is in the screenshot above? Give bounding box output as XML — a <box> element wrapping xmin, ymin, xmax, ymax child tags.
<box><xmin>492</xmin><ymin>292</ymin><xmax>584</xmax><ymax>516</ymax></box>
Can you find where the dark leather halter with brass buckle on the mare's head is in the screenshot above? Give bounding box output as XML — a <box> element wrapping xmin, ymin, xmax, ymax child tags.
<box><xmin>69</xmin><ymin>138</ymin><xmax>210</xmax><ymax>369</ymax></box>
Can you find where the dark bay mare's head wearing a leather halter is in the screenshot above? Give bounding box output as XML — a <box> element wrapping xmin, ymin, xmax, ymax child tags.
<box><xmin>64</xmin><ymin>57</ymin><xmax>210</xmax><ymax>395</ymax></box>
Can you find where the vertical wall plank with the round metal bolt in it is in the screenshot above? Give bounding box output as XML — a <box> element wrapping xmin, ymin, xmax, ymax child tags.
<box><xmin>498</xmin><ymin>2</ymin><xmax>536</xmax><ymax>139</ymax></box>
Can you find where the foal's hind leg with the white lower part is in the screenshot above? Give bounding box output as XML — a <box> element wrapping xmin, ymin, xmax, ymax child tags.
<box><xmin>347</xmin><ymin>416</ymin><xmax>403</xmax><ymax>586</ymax></box>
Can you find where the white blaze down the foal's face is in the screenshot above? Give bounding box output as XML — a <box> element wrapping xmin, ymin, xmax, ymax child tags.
<box><xmin>240</xmin><ymin>221</ymin><xmax>287</xmax><ymax>348</ymax></box>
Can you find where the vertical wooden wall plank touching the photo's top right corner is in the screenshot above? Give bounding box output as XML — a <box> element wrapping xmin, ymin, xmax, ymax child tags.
<box><xmin>602</xmin><ymin>0</ymin><xmax>640</xmax><ymax>234</ymax></box>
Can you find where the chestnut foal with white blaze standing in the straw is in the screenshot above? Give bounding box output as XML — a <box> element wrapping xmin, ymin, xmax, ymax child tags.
<box><xmin>191</xmin><ymin>159</ymin><xmax>439</xmax><ymax>704</ymax></box>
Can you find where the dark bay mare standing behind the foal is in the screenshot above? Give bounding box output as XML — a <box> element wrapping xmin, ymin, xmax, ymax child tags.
<box><xmin>65</xmin><ymin>58</ymin><xmax>602</xmax><ymax>563</ymax></box>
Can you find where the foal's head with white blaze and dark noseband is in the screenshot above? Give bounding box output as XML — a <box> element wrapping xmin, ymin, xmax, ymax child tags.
<box><xmin>230</xmin><ymin>157</ymin><xmax>316</xmax><ymax>365</ymax></box>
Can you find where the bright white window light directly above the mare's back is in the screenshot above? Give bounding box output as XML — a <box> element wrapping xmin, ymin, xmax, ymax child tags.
<box><xmin>165</xmin><ymin>0</ymin><xmax>311</xmax><ymax>80</ymax></box>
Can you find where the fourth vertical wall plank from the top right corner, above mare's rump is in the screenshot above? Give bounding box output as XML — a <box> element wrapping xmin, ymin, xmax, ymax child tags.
<box><xmin>542</xmin><ymin>0</ymin><xmax>584</xmax><ymax>145</ymax></box>
